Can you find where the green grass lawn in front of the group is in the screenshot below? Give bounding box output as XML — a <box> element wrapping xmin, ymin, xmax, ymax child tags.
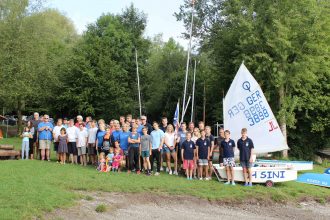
<box><xmin>0</xmin><ymin>138</ymin><xmax>330</xmax><ymax>219</ymax></box>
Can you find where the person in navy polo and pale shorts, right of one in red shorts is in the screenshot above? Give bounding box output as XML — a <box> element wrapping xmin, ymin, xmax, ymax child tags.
<box><xmin>196</xmin><ymin>130</ymin><xmax>211</xmax><ymax>180</ymax></box>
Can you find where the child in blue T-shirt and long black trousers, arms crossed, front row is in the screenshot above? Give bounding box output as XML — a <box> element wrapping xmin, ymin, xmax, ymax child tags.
<box><xmin>127</xmin><ymin>125</ymin><xmax>141</xmax><ymax>175</ymax></box>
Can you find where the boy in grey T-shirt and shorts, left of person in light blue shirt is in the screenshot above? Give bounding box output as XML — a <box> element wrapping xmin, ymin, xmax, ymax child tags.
<box><xmin>140</xmin><ymin>127</ymin><xmax>152</xmax><ymax>176</ymax></box>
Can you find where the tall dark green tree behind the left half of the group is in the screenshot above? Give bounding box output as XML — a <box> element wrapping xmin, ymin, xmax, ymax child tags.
<box><xmin>55</xmin><ymin>6</ymin><xmax>149</xmax><ymax>119</ymax></box>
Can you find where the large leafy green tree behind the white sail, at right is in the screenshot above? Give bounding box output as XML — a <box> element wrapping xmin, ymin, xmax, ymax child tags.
<box><xmin>177</xmin><ymin>0</ymin><xmax>330</xmax><ymax>157</ymax></box>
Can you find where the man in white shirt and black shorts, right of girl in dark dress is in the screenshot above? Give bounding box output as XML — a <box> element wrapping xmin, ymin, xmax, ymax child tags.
<box><xmin>66</xmin><ymin>119</ymin><xmax>78</xmax><ymax>164</ymax></box>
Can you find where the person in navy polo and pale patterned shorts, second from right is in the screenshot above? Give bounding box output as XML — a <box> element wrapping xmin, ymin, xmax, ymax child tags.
<box><xmin>221</xmin><ymin>130</ymin><xmax>236</xmax><ymax>186</ymax></box>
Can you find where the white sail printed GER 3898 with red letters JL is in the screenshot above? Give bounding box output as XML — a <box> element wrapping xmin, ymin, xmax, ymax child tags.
<box><xmin>223</xmin><ymin>63</ymin><xmax>288</xmax><ymax>154</ymax></box>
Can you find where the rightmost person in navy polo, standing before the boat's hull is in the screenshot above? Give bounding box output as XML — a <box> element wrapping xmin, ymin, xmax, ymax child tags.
<box><xmin>237</xmin><ymin>128</ymin><xmax>254</xmax><ymax>186</ymax></box>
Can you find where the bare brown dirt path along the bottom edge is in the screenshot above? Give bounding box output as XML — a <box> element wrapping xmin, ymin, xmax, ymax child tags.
<box><xmin>44</xmin><ymin>192</ymin><xmax>330</xmax><ymax>220</ymax></box>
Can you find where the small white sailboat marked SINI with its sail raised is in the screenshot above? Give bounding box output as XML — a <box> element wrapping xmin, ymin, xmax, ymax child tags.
<box><xmin>214</xmin><ymin>63</ymin><xmax>297</xmax><ymax>187</ymax></box>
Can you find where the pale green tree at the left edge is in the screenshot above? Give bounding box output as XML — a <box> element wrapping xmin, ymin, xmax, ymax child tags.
<box><xmin>0</xmin><ymin>0</ymin><xmax>75</xmax><ymax>131</ymax></box>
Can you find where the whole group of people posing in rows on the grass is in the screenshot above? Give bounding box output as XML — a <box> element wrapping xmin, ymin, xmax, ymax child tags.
<box><xmin>22</xmin><ymin>113</ymin><xmax>254</xmax><ymax>186</ymax></box>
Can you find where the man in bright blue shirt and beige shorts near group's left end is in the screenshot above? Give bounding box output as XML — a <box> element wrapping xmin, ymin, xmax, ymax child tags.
<box><xmin>38</xmin><ymin>115</ymin><xmax>54</xmax><ymax>161</ymax></box>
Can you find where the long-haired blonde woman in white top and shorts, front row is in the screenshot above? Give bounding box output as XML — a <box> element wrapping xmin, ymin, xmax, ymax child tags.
<box><xmin>164</xmin><ymin>124</ymin><xmax>178</xmax><ymax>175</ymax></box>
